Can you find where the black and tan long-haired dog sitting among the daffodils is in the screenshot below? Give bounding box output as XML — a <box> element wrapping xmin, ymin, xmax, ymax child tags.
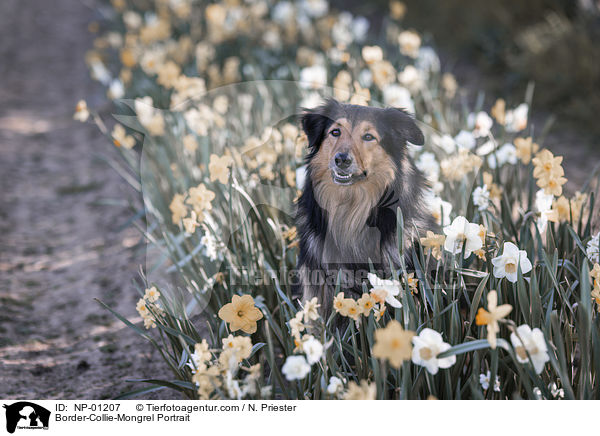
<box><xmin>296</xmin><ymin>99</ymin><xmax>436</xmax><ymax>314</ymax></box>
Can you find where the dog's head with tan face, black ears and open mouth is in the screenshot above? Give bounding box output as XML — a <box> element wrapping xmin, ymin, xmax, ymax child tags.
<box><xmin>302</xmin><ymin>99</ymin><xmax>424</xmax><ymax>189</ymax></box>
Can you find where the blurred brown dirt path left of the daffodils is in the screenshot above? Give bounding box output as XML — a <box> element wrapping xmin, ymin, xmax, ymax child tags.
<box><xmin>0</xmin><ymin>0</ymin><xmax>172</xmax><ymax>399</ymax></box>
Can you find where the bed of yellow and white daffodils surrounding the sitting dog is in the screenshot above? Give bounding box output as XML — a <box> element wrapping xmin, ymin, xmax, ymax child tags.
<box><xmin>76</xmin><ymin>0</ymin><xmax>600</xmax><ymax>399</ymax></box>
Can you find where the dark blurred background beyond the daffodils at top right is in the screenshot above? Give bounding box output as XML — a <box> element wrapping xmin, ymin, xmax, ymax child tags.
<box><xmin>346</xmin><ymin>0</ymin><xmax>600</xmax><ymax>135</ymax></box>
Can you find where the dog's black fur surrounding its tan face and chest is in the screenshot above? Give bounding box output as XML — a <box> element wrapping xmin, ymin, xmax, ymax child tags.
<box><xmin>297</xmin><ymin>100</ymin><xmax>436</xmax><ymax>312</ymax></box>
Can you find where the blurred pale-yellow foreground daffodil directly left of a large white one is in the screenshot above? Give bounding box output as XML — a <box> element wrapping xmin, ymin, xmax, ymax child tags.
<box><xmin>373</xmin><ymin>319</ymin><xmax>415</xmax><ymax>368</ymax></box>
